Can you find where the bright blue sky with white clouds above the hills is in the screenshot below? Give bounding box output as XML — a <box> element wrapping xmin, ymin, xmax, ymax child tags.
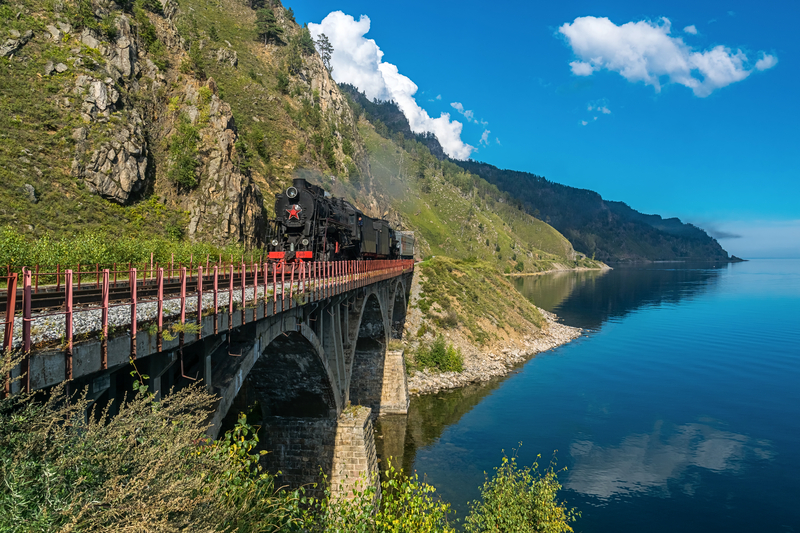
<box><xmin>285</xmin><ymin>0</ymin><xmax>800</xmax><ymax>258</ymax></box>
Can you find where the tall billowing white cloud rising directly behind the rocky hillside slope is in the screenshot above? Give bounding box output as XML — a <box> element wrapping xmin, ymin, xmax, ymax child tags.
<box><xmin>308</xmin><ymin>11</ymin><xmax>475</xmax><ymax>159</ymax></box>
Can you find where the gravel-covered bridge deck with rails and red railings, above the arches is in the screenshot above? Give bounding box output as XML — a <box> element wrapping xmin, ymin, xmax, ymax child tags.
<box><xmin>0</xmin><ymin>260</ymin><xmax>413</xmax><ymax>394</ymax></box>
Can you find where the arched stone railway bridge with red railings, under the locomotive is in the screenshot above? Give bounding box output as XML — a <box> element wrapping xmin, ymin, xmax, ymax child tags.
<box><xmin>0</xmin><ymin>259</ymin><xmax>414</xmax><ymax>492</ymax></box>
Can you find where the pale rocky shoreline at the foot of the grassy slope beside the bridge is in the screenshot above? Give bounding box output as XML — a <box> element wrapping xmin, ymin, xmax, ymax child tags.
<box><xmin>408</xmin><ymin>309</ymin><xmax>583</xmax><ymax>396</ymax></box>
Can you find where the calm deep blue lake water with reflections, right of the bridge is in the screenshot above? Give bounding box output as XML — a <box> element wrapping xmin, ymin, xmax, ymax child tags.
<box><xmin>378</xmin><ymin>260</ymin><xmax>800</xmax><ymax>533</ymax></box>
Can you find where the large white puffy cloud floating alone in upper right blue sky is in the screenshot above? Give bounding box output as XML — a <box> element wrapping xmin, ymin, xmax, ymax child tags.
<box><xmin>558</xmin><ymin>17</ymin><xmax>777</xmax><ymax>98</ymax></box>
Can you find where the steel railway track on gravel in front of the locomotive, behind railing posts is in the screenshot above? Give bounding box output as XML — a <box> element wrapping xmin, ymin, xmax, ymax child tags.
<box><xmin>0</xmin><ymin>273</ymin><xmax>256</xmax><ymax>315</ymax></box>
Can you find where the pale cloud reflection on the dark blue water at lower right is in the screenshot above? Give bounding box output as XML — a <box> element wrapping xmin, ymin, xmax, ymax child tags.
<box><xmin>564</xmin><ymin>421</ymin><xmax>773</xmax><ymax>500</ymax></box>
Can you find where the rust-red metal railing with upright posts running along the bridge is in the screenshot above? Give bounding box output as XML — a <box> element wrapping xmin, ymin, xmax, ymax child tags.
<box><xmin>0</xmin><ymin>258</ymin><xmax>414</xmax><ymax>394</ymax></box>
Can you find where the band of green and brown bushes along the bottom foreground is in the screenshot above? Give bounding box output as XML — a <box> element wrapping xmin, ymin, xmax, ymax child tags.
<box><xmin>0</xmin><ymin>356</ymin><xmax>576</xmax><ymax>533</ymax></box>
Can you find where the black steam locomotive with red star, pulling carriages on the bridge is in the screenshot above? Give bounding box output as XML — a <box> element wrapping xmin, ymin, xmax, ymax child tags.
<box><xmin>267</xmin><ymin>178</ymin><xmax>414</xmax><ymax>262</ymax></box>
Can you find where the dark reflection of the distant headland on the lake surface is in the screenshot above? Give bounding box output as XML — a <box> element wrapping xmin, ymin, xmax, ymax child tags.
<box><xmin>514</xmin><ymin>263</ymin><xmax>736</xmax><ymax>329</ymax></box>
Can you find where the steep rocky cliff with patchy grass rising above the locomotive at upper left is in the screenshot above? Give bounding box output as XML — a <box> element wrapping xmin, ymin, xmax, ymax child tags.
<box><xmin>0</xmin><ymin>0</ymin><xmax>369</xmax><ymax>245</ymax></box>
